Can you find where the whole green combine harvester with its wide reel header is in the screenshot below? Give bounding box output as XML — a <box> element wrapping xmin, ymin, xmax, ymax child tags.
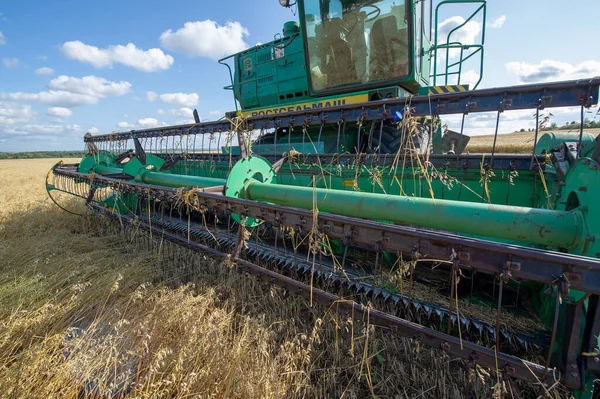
<box><xmin>47</xmin><ymin>0</ymin><xmax>600</xmax><ymax>397</ymax></box>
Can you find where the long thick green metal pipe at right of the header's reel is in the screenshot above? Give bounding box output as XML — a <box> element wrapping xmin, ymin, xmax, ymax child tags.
<box><xmin>242</xmin><ymin>180</ymin><xmax>583</xmax><ymax>248</ymax></box>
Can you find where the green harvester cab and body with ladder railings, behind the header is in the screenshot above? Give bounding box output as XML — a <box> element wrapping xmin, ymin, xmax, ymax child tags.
<box><xmin>220</xmin><ymin>0</ymin><xmax>486</xmax><ymax>154</ymax></box>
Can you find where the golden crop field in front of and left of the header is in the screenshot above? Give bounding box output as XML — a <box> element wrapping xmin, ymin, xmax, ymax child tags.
<box><xmin>0</xmin><ymin>159</ymin><xmax>563</xmax><ymax>398</ymax></box>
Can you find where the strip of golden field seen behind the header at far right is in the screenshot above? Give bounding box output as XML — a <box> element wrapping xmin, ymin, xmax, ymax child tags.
<box><xmin>467</xmin><ymin>129</ymin><xmax>600</xmax><ymax>154</ymax></box>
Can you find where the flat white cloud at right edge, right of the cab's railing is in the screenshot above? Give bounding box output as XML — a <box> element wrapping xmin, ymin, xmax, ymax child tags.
<box><xmin>506</xmin><ymin>60</ymin><xmax>600</xmax><ymax>83</ymax></box>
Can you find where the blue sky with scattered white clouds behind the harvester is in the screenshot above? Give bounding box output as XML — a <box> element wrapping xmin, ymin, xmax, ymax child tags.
<box><xmin>0</xmin><ymin>0</ymin><xmax>600</xmax><ymax>151</ymax></box>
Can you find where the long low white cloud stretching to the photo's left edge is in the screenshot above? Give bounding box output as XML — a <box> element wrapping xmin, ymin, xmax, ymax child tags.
<box><xmin>0</xmin><ymin>75</ymin><xmax>131</xmax><ymax>108</ymax></box>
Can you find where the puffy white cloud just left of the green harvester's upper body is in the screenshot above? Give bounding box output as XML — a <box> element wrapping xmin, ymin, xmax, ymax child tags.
<box><xmin>160</xmin><ymin>19</ymin><xmax>249</xmax><ymax>60</ymax></box>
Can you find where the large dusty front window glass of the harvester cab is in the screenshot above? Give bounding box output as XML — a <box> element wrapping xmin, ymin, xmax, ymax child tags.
<box><xmin>304</xmin><ymin>0</ymin><xmax>410</xmax><ymax>92</ymax></box>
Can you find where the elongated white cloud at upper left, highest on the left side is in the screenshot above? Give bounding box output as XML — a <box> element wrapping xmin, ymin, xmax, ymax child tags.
<box><xmin>61</xmin><ymin>40</ymin><xmax>174</xmax><ymax>72</ymax></box>
